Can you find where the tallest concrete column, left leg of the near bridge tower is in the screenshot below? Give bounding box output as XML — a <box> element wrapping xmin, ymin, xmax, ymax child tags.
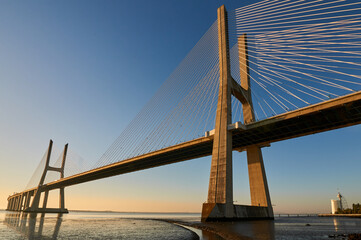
<box><xmin>202</xmin><ymin>6</ymin><xmax>234</xmax><ymax>221</ymax></box>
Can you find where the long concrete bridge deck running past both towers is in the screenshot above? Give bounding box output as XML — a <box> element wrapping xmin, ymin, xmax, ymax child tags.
<box><xmin>9</xmin><ymin>92</ymin><xmax>361</xmax><ymax>198</ymax></box>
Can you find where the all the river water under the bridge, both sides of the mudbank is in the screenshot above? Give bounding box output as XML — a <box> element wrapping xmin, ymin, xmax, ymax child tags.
<box><xmin>0</xmin><ymin>211</ymin><xmax>361</xmax><ymax>240</ymax></box>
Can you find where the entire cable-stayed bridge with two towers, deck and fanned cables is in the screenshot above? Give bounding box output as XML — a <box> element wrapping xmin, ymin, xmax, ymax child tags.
<box><xmin>7</xmin><ymin>0</ymin><xmax>361</xmax><ymax>220</ymax></box>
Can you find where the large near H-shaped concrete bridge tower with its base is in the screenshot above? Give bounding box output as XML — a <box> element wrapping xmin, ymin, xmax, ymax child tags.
<box><xmin>202</xmin><ymin>5</ymin><xmax>273</xmax><ymax>221</ymax></box>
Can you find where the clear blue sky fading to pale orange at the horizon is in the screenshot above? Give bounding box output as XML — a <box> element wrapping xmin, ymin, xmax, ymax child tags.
<box><xmin>0</xmin><ymin>0</ymin><xmax>361</xmax><ymax>213</ymax></box>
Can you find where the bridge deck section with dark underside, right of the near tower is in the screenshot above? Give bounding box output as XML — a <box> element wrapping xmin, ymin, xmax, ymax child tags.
<box><xmin>233</xmin><ymin>92</ymin><xmax>361</xmax><ymax>150</ymax></box>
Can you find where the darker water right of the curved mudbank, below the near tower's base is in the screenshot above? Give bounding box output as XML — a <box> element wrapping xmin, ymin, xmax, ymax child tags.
<box><xmin>193</xmin><ymin>216</ymin><xmax>361</xmax><ymax>240</ymax></box>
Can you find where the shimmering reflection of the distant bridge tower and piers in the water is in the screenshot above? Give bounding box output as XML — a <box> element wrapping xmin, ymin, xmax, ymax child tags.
<box><xmin>4</xmin><ymin>213</ymin><xmax>63</xmax><ymax>239</ymax></box>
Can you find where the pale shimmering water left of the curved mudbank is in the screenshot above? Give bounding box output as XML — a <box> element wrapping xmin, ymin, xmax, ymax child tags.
<box><xmin>0</xmin><ymin>211</ymin><xmax>197</xmax><ymax>240</ymax></box>
